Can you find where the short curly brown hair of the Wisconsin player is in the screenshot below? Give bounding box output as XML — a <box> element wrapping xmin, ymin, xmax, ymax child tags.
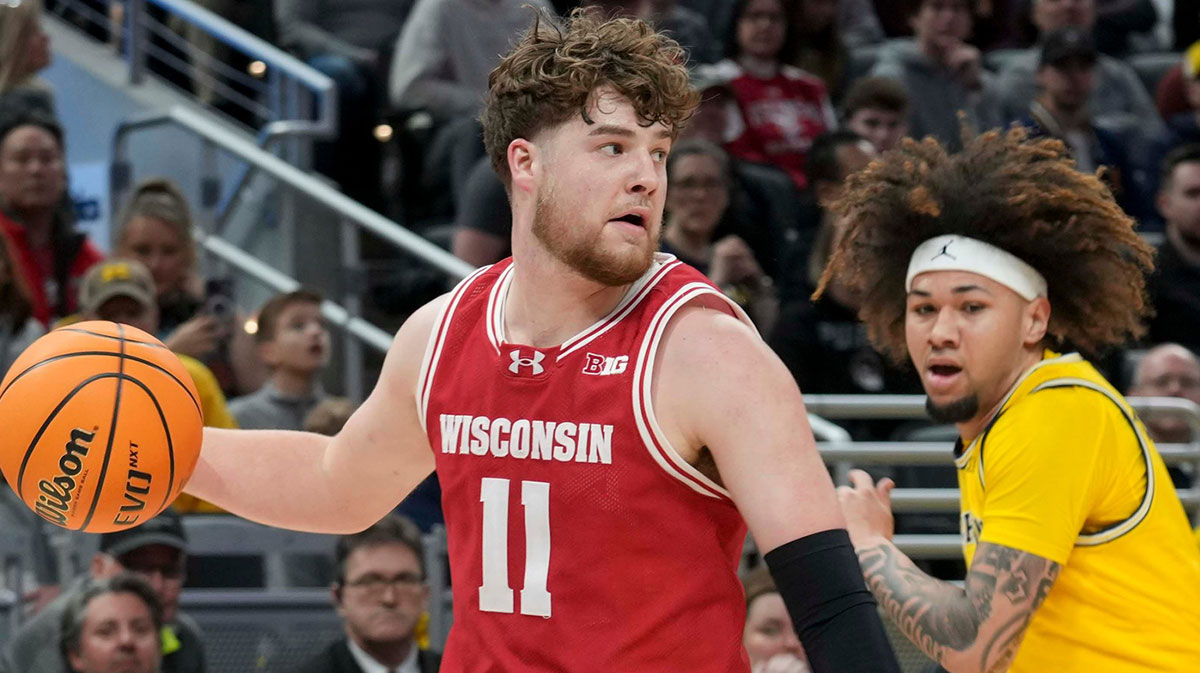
<box><xmin>480</xmin><ymin>8</ymin><xmax>700</xmax><ymax>186</ymax></box>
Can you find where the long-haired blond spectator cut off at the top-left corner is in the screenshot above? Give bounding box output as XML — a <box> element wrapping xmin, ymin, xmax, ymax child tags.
<box><xmin>0</xmin><ymin>0</ymin><xmax>54</xmax><ymax>116</ymax></box>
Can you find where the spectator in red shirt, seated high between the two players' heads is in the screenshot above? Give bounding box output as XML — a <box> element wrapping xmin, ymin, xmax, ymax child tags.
<box><xmin>696</xmin><ymin>0</ymin><xmax>836</xmax><ymax>188</ymax></box>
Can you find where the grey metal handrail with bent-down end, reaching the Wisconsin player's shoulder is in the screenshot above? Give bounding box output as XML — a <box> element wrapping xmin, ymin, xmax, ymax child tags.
<box><xmin>112</xmin><ymin>106</ymin><xmax>475</xmax><ymax>280</ymax></box>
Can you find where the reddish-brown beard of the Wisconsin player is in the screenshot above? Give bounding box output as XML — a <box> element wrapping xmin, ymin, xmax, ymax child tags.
<box><xmin>533</xmin><ymin>181</ymin><xmax>656</xmax><ymax>287</ymax></box>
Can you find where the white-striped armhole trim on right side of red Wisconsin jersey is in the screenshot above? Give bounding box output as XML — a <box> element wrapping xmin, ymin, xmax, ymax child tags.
<box><xmin>632</xmin><ymin>282</ymin><xmax>757</xmax><ymax>500</ymax></box>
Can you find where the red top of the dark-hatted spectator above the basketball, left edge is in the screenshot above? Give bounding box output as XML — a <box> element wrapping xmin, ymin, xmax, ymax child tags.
<box><xmin>0</xmin><ymin>211</ymin><xmax>104</xmax><ymax>326</ymax></box>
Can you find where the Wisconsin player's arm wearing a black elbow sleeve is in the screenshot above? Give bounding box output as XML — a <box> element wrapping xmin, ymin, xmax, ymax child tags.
<box><xmin>653</xmin><ymin>305</ymin><xmax>900</xmax><ymax>673</ymax></box>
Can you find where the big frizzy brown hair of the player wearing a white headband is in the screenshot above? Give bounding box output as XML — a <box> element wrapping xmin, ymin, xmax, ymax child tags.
<box><xmin>814</xmin><ymin>128</ymin><xmax>1153</xmax><ymax>362</ymax></box>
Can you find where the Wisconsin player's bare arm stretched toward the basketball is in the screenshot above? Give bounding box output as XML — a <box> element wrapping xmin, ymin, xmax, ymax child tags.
<box><xmin>185</xmin><ymin>298</ymin><xmax>446</xmax><ymax>534</ymax></box>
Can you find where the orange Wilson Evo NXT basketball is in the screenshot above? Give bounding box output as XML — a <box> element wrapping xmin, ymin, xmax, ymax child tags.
<box><xmin>0</xmin><ymin>322</ymin><xmax>204</xmax><ymax>533</ymax></box>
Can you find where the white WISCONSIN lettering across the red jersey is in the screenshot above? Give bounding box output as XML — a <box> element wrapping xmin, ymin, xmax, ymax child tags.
<box><xmin>439</xmin><ymin>414</ymin><xmax>612</xmax><ymax>465</ymax></box>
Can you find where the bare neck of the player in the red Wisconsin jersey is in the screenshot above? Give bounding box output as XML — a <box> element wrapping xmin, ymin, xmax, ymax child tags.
<box><xmin>504</xmin><ymin>251</ymin><xmax>629</xmax><ymax>348</ymax></box>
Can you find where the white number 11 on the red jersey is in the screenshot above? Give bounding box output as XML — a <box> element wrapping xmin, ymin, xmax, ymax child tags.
<box><xmin>479</xmin><ymin>477</ymin><xmax>550</xmax><ymax>617</ymax></box>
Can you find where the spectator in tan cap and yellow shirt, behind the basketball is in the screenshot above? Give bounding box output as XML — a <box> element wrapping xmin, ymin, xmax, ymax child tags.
<box><xmin>79</xmin><ymin>259</ymin><xmax>238</xmax><ymax>513</ymax></box>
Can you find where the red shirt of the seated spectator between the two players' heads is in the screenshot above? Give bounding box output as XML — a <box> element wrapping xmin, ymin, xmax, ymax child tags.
<box><xmin>715</xmin><ymin>61</ymin><xmax>838</xmax><ymax>190</ymax></box>
